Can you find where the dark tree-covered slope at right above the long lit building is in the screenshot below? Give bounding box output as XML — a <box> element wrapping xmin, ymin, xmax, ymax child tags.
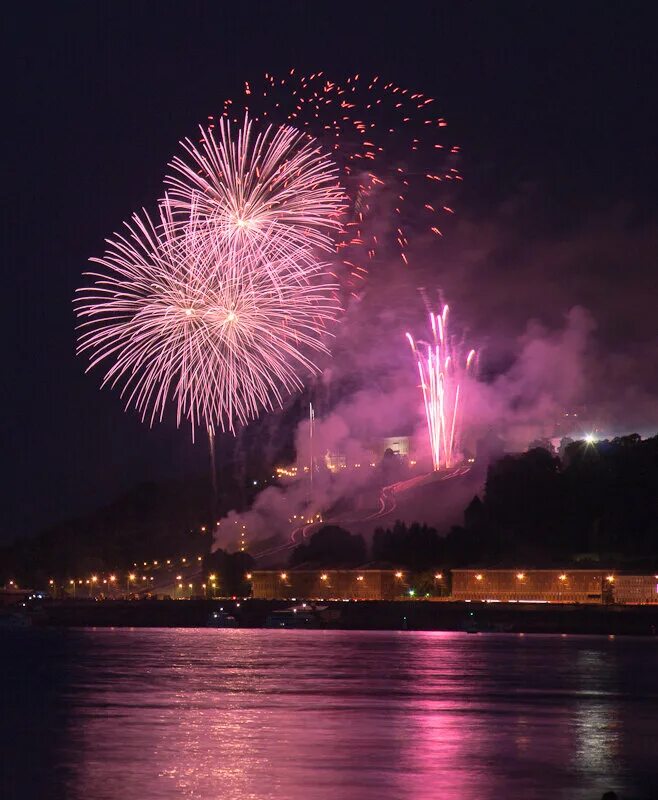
<box><xmin>462</xmin><ymin>434</ymin><xmax>658</xmax><ymax>568</ymax></box>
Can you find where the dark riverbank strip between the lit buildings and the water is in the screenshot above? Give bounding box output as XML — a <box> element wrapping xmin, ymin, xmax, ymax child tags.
<box><xmin>18</xmin><ymin>599</ymin><xmax>658</xmax><ymax>636</ymax></box>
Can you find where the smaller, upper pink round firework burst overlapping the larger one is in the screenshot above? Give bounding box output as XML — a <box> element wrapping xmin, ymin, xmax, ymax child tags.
<box><xmin>165</xmin><ymin>114</ymin><xmax>345</xmax><ymax>264</ymax></box>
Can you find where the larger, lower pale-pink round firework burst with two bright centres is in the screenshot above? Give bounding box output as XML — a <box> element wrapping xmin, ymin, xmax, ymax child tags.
<box><xmin>76</xmin><ymin>205</ymin><xmax>338</xmax><ymax>435</ymax></box>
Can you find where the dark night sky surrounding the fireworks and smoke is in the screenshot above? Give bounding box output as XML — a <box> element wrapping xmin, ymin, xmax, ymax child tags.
<box><xmin>0</xmin><ymin>0</ymin><xmax>658</xmax><ymax>541</ymax></box>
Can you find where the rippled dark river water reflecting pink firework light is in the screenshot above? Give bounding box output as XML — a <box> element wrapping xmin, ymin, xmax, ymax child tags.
<box><xmin>0</xmin><ymin>630</ymin><xmax>658</xmax><ymax>800</ymax></box>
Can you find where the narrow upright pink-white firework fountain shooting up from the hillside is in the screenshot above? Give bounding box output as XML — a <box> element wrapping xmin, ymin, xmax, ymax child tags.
<box><xmin>406</xmin><ymin>305</ymin><xmax>476</xmax><ymax>470</ymax></box>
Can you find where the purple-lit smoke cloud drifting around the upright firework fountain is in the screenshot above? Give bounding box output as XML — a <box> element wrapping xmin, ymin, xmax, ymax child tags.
<box><xmin>216</xmin><ymin>195</ymin><xmax>658</xmax><ymax>546</ymax></box>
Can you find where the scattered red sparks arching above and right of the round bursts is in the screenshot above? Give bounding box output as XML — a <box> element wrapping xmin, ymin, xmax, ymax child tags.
<box><xmin>213</xmin><ymin>69</ymin><xmax>462</xmax><ymax>290</ymax></box>
